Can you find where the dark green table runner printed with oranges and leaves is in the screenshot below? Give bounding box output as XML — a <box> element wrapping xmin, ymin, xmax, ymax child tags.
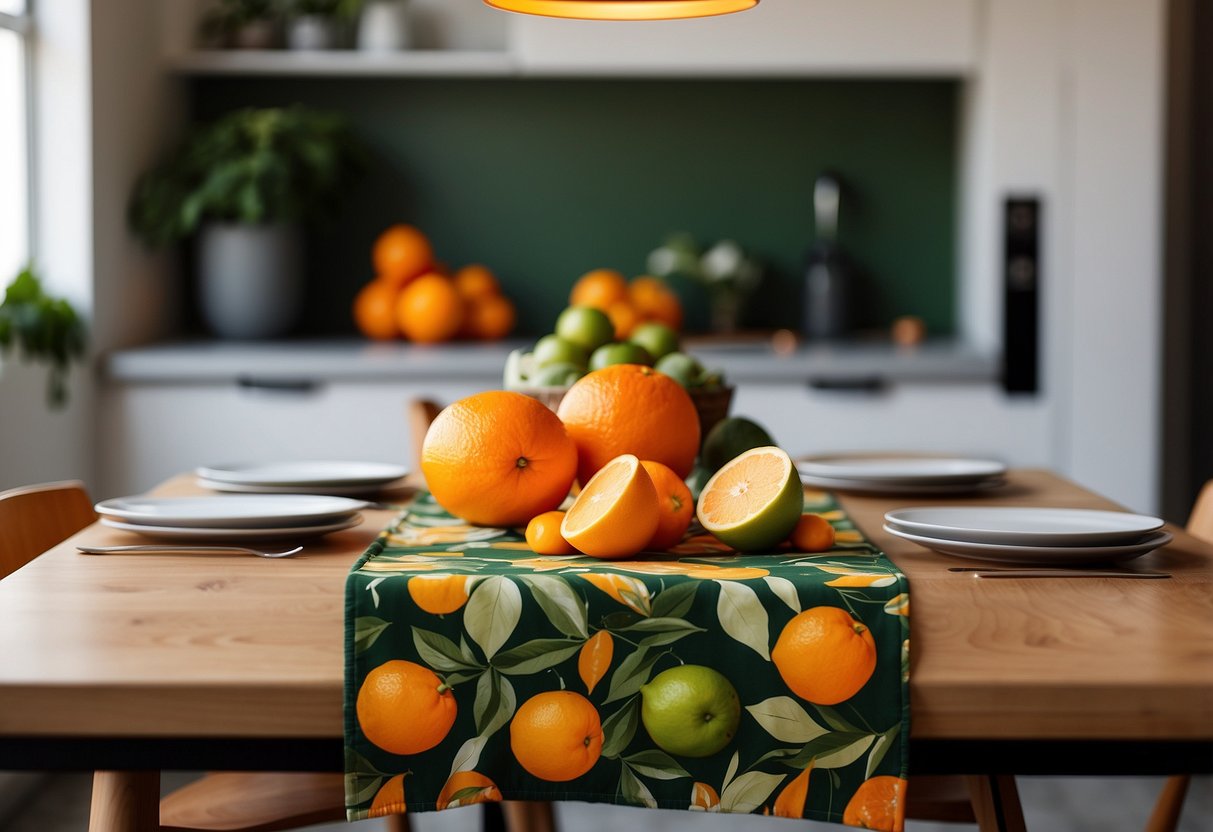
<box><xmin>344</xmin><ymin>492</ymin><xmax>910</xmax><ymax>830</ymax></box>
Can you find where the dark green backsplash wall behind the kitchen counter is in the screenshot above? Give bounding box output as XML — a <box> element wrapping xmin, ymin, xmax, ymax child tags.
<box><xmin>190</xmin><ymin>78</ymin><xmax>958</xmax><ymax>335</ymax></box>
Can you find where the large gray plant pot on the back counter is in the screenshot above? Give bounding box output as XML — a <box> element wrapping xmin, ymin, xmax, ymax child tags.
<box><xmin>198</xmin><ymin>222</ymin><xmax>303</xmax><ymax>340</ymax></box>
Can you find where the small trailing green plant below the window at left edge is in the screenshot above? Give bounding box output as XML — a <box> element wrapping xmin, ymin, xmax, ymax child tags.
<box><xmin>0</xmin><ymin>266</ymin><xmax>85</xmax><ymax>408</ymax></box>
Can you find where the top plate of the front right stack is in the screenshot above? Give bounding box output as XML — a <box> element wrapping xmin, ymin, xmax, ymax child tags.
<box><xmin>884</xmin><ymin>506</ymin><xmax>1162</xmax><ymax>546</ymax></box>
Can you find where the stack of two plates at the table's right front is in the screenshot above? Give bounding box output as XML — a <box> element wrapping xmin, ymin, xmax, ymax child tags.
<box><xmin>884</xmin><ymin>506</ymin><xmax>1171</xmax><ymax>566</ymax></box>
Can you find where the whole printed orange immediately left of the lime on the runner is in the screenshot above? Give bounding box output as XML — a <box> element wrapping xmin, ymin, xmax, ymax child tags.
<box><xmin>509</xmin><ymin>690</ymin><xmax>603</xmax><ymax>782</ymax></box>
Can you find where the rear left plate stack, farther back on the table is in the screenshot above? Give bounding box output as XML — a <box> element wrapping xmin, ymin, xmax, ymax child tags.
<box><xmin>194</xmin><ymin>460</ymin><xmax>409</xmax><ymax>495</ymax></box>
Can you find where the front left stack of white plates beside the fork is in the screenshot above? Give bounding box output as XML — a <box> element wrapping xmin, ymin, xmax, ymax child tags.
<box><xmin>96</xmin><ymin>495</ymin><xmax>368</xmax><ymax>542</ymax></box>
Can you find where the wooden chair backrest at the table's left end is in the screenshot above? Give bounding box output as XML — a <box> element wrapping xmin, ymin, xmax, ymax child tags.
<box><xmin>0</xmin><ymin>480</ymin><xmax>97</xmax><ymax>577</ymax></box>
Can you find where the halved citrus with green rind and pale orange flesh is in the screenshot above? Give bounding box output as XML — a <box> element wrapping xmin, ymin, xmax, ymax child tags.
<box><xmin>695</xmin><ymin>445</ymin><xmax>804</xmax><ymax>552</ymax></box>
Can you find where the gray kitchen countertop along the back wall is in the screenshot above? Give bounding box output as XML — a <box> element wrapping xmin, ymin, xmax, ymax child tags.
<box><xmin>103</xmin><ymin>338</ymin><xmax>1000</xmax><ymax>387</ymax></box>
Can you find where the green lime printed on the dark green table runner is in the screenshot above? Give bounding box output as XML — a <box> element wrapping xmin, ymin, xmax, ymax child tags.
<box><xmin>640</xmin><ymin>665</ymin><xmax>741</xmax><ymax>757</ymax></box>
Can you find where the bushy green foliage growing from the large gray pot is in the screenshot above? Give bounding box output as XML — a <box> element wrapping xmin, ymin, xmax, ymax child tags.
<box><xmin>129</xmin><ymin>107</ymin><xmax>361</xmax><ymax>246</ymax></box>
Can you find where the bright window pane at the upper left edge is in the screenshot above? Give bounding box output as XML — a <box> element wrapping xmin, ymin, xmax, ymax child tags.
<box><xmin>0</xmin><ymin>0</ymin><xmax>33</xmax><ymax>287</ymax></box>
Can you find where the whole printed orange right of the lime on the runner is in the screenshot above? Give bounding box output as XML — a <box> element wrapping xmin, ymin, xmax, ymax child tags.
<box><xmin>770</xmin><ymin>606</ymin><xmax>876</xmax><ymax>705</ymax></box>
